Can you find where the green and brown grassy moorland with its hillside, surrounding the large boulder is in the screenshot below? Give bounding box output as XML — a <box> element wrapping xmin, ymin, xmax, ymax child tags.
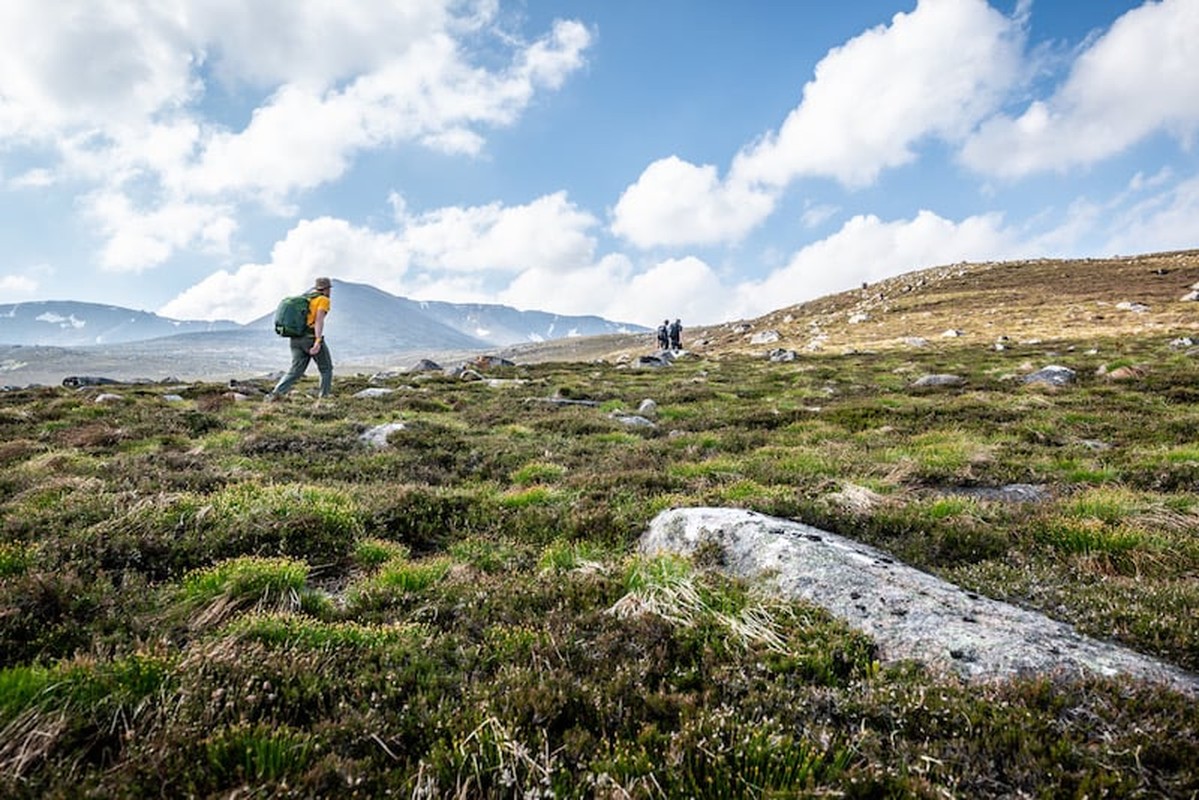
<box><xmin>0</xmin><ymin>255</ymin><xmax>1199</xmax><ymax>798</ymax></box>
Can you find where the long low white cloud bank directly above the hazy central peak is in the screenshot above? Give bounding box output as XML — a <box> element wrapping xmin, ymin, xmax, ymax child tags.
<box><xmin>158</xmin><ymin>193</ymin><xmax>727</xmax><ymax>325</ymax></box>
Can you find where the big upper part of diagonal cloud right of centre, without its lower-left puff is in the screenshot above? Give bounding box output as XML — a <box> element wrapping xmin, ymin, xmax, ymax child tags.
<box><xmin>731</xmin><ymin>0</ymin><xmax>1023</xmax><ymax>186</ymax></box>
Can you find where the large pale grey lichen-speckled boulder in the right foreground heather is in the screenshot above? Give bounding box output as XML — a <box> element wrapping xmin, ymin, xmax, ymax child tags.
<box><xmin>640</xmin><ymin>509</ymin><xmax>1199</xmax><ymax>696</ymax></box>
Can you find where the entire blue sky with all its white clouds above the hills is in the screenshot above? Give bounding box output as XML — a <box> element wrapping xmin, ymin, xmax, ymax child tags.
<box><xmin>0</xmin><ymin>0</ymin><xmax>1199</xmax><ymax>332</ymax></box>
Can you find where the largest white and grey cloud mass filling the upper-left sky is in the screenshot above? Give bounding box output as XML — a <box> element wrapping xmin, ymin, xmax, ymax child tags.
<box><xmin>0</xmin><ymin>0</ymin><xmax>591</xmax><ymax>270</ymax></box>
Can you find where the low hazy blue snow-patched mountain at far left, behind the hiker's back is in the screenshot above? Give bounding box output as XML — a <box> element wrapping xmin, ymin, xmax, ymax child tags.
<box><xmin>0</xmin><ymin>300</ymin><xmax>241</xmax><ymax>347</ymax></box>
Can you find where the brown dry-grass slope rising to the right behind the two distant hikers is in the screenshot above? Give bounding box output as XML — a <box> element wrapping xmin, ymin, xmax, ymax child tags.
<box><xmin>522</xmin><ymin>249</ymin><xmax>1199</xmax><ymax>363</ymax></box>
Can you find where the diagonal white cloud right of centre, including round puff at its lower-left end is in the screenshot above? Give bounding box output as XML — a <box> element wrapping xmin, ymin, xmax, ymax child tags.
<box><xmin>611</xmin><ymin>0</ymin><xmax>1023</xmax><ymax>247</ymax></box>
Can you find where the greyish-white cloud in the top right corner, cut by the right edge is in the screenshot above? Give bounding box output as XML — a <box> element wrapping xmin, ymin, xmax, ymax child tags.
<box><xmin>962</xmin><ymin>0</ymin><xmax>1199</xmax><ymax>178</ymax></box>
